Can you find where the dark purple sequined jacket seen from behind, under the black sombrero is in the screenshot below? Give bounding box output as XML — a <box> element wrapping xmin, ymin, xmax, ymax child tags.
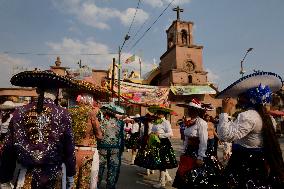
<box><xmin>0</xmin><ymin>99</ymin><xmax>75</xmax><ymax>183</ymax></box>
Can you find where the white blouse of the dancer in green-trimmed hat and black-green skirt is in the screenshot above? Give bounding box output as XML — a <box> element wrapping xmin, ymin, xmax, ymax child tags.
<box><xmin>152</xmin><ymin>118</ymin><xmax>173</xmax><ymax>138</ymax></box>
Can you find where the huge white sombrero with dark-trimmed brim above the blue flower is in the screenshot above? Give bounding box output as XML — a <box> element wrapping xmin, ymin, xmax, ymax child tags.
<box><xmin>215</xmin><ymin>72</ymin><xmax>283</xmax><ymax>98</ymax></box>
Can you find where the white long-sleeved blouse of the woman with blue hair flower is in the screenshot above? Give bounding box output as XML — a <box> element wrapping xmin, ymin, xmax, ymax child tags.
<box><xmin>217</xmin><ymin>110</ymin><xmax>263</xmax><ymax>148</ymax></box>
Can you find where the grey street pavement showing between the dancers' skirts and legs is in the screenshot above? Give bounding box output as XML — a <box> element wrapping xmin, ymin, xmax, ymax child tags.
<box><xmin>114</xmin><ymin>137</ymin><xmax>284</xmax><ymax>189</ymax></box>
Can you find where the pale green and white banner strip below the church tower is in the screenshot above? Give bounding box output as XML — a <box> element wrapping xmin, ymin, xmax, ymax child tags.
<box><xmin>170</xmin><ymin>85</ymin><xmax>216</xmax><ymax>95</ymax></box>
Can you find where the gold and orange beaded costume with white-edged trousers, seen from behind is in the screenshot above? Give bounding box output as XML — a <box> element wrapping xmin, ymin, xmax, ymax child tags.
<box><xmin>69</xmin><ymin>104</ymin><xmax>99</xmax><ymax>189</ymax></box>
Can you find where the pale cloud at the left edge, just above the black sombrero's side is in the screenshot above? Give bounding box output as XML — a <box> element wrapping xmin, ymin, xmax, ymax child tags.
<box><xmin>0</xmin><ymin>54</ymin><xmax>30</xmax><ymax>87</ymax></box>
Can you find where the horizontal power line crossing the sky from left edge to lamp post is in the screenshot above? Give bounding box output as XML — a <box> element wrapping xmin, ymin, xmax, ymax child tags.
<box><xmin>0</xmin><ymin>51</ymin><xmax>117</xmax><ymax>56</ymax></box>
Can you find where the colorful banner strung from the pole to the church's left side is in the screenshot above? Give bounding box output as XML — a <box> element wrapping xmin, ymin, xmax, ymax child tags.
<box><xmin>113</xmin><ymin>81</ymin><xmax>170</xmax><ymax>106</ymax></box>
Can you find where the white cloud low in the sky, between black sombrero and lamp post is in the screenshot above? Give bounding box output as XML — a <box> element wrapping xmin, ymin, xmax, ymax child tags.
<box><xmin>47</xmin><ymin>38</ymin><xmax>114</xmax><ymax>69</ymax></box>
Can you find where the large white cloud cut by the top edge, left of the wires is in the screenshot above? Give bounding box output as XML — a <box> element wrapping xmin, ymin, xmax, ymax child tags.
<box><xmin>52</xmin><ymin>0</ymin><xmax>149</xmax><ymax>29</ymax></box>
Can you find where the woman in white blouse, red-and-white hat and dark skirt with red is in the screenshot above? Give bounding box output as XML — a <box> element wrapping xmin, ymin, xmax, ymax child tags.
<box><xmin>173</xmin><ymin>99</ymin><xmax>221</xmax><ymax>189</ymax></box>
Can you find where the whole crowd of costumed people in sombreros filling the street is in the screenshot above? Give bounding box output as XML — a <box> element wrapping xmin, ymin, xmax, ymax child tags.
<box><xmin>0</xmin><ymin>71</ymin><xmax>284</xmax><ymax>189</ymax></box>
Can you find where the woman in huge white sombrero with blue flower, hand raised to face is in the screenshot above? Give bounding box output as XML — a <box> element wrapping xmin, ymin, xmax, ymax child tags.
<box><xmin>216</xmin><ymin>72</ymin><xmax>284</xmax><ymax>189</ymax></box>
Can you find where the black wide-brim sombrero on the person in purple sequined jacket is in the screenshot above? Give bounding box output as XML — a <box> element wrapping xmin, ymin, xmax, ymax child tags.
<box><xmin>10</xmin><ymin>70</ymin><xmax>74</xmax><ymax>88</ymax></box>
